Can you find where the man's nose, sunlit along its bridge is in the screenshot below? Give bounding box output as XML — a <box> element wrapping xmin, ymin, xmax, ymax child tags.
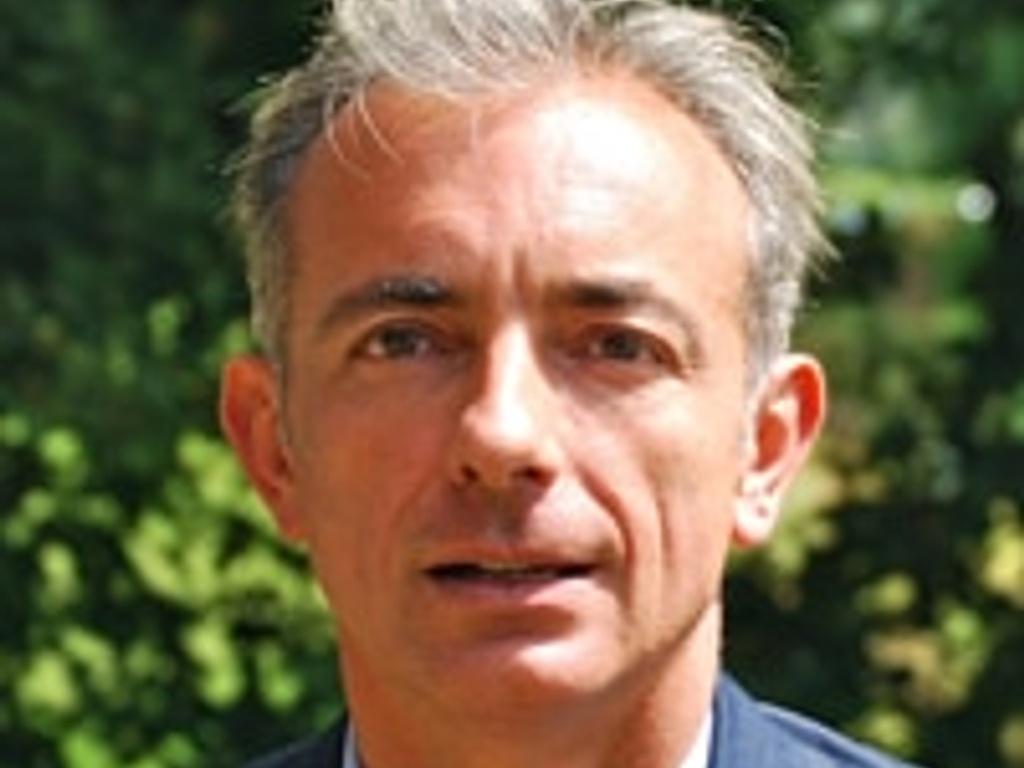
<box><xmin>451</xmin><ymin>331</ymin><xmax>561</xmax><ymax>490</ymax></box>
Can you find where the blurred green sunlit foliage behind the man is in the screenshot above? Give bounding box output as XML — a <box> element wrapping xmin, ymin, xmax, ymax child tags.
<box><xmin>0</xmin><ymin>0</ymin><xmax>1024</xmax><ymax>768</ymax></box>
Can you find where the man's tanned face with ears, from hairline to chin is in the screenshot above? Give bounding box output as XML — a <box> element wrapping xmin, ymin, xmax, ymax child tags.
<box><xmin>225</xmin><ymin>79</ymin><xmax>816</xmax><ymax>724</ymax></box>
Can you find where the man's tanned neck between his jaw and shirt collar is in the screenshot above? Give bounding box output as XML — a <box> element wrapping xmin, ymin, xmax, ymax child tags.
<box><xmin>347</xmin><ymin>606</ymin><xmax>721</xmax><ymax>768</ymax></box>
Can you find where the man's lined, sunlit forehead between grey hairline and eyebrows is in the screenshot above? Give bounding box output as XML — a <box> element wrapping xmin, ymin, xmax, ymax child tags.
<box><xmin>288</xmin><ymin>76</ymin><xmax>749</xmax><ymax>294</ymax></box>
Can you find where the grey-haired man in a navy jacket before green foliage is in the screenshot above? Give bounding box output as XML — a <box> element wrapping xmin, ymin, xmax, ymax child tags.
<box><xmin>222</xmin><ymin>0</ymin><xmax>917</xmax><ymax>768</ymax></box>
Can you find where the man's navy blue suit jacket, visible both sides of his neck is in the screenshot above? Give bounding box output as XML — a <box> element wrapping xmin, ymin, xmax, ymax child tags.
<box><xmin>248</xmin><ymin>677</ymin><xmax>907</xmax><ymax>768</ymax></box>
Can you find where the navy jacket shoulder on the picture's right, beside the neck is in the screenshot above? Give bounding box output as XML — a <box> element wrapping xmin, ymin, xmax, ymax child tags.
<box><xmin>712</xmin><ymin>678</ymin><xmax>909</xmax><ymax>768</ymax></box>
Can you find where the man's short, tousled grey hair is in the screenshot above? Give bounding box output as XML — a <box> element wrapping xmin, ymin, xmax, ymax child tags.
<box><xmin>233</xmin><ymin>0</ymin><xmax>828</xmax><ymax>376</ymax></box>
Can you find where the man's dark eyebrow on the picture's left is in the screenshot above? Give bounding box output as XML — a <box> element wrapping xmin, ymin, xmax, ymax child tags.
<box><xmin>316</xmin><ymin>274</ymin><xmax>460</xmax><ymax>336</ymax></box>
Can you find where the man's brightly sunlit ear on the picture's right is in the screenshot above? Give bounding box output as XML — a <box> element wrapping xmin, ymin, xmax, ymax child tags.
<box><xmin>733</xmin><ymin>354</ymin><xmax>825</xmax><ymax>547</ymax></box>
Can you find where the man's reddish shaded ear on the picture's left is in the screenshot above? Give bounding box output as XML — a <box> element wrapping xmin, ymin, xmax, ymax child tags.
<box><xmin>220</xmin><ymin>356</ymin><xmax>304</xmax><ymax>541</ymax></box>
